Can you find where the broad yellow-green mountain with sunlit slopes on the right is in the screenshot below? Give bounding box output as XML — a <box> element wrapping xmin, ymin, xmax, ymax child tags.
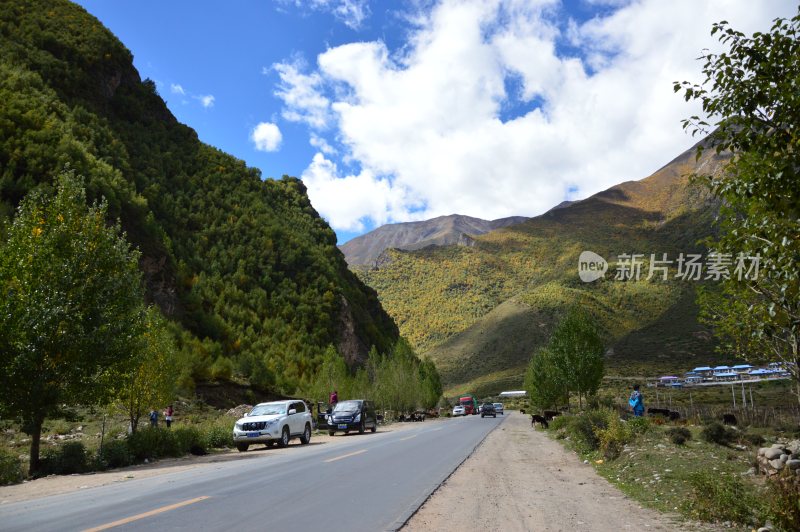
<box><xmin>358</xmin><ymin>139</ymin><xmax>725</xmax><ymax>395</ymax></box>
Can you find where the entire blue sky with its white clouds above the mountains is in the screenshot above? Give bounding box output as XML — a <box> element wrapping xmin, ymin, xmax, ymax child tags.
<box><xmin>73</xmin><ymin>0</ymin><xmax>797</xmax><ymax>243</ymax></box>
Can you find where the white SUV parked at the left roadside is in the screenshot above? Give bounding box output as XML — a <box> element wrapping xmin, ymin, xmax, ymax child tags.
<box><xmin>233</xmin><ymin>400</ymin><xmax>311</xmax><ymax>452</ymax></box>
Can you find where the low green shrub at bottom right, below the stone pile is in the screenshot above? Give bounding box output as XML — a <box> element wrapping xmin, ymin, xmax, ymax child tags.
<box><xmin>683</xmin><ymin>471</ymin><xmax>764</xmax><ymax>524</ymax></box>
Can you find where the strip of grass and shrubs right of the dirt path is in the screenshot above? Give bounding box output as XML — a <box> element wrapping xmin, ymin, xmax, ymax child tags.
<box><xmin>548</xmin><ymin>407</ymin><xmax>800</xmax><ymax>531</ymax></box>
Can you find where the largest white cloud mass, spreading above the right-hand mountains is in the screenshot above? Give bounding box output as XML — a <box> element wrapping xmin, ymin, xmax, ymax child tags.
<box><xmin>274</xmin><ymin>0</ymin><xmax>795</xmax><ymax>230</ymax></box>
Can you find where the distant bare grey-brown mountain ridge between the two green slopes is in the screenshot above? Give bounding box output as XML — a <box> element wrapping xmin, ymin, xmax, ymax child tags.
<box><xmin>339</xmin><ymin>214</ymin><xmax>527</xmax><ymax>267</ymax></box>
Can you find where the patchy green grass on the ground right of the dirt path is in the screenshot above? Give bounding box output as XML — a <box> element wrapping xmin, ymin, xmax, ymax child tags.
<box><xmin>549</xmin><ymin>411</ymin><xmax>791</xmax><ymax>530</ymax></box>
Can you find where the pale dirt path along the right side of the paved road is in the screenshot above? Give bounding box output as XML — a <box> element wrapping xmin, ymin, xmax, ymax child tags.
<box><xmin>402</xmin><ymin>412</ymin><xmax>716</xmax><ymax>532</ymax></box>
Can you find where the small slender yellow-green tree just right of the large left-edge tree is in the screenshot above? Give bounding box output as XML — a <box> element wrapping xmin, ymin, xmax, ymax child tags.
<box><xmin>117</xmin><ymin>307</ymin><xmax>177</xmax><ymax>432</ymax></box>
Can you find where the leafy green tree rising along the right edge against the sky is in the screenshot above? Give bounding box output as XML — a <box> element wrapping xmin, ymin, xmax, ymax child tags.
<box><xmin>674</xmin><ymin>9</ymin><xmax>800</xmax><ymax>399</ymax></box>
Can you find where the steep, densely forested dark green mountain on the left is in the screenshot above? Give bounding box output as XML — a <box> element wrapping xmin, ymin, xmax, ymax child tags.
<box><xmin>0</xmin><ymin>0</ymin><xmax>398</xmax><ymax>393</ymax></box>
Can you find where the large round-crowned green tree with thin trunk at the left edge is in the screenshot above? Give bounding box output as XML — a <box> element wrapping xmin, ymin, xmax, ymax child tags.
<box><xmin>0</xmin><ymin>174</ymin><xmax>144</xmax><ymax>473</ymax></box>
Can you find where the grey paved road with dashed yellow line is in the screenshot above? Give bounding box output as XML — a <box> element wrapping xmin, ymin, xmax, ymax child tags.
<box><xmin>0</xmin><ymin>416</ymin><xmax>503</xmax><ymax>532</ymax></box>
